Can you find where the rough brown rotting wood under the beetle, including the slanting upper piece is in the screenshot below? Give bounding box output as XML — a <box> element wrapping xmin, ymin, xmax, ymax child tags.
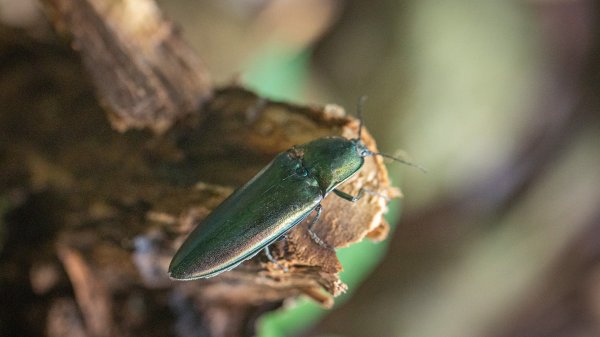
<box><xmin>0</xmin><ymin>0</ymin><xmax>399</xmax><ymax>336</ymax></box>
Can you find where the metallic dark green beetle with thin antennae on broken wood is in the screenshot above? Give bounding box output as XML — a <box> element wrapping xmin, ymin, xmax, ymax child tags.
<box><xmin>169</xmin><ymin>98</ymin><xmax>422</xmax><ymax>280</ymax></box>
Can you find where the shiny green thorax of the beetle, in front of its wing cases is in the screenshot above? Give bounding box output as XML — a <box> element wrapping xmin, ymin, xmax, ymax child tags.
<box><xmin>291</xmin><ymin>137</ymin><xmax>364</xmax><ymax>195</ymax></box>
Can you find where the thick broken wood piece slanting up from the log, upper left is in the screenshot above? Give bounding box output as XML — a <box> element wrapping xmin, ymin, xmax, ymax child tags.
<box><xmin>44</xmin><ymin>0</ymin><xmax>212</xmax><ymax>132</ymax></box>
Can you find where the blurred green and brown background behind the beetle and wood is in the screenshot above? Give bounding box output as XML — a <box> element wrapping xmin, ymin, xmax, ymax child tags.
<box><xmin>0</xmin><ymin>0</ymin><xmax>600</xmax><ymax>337</ymax></box>
